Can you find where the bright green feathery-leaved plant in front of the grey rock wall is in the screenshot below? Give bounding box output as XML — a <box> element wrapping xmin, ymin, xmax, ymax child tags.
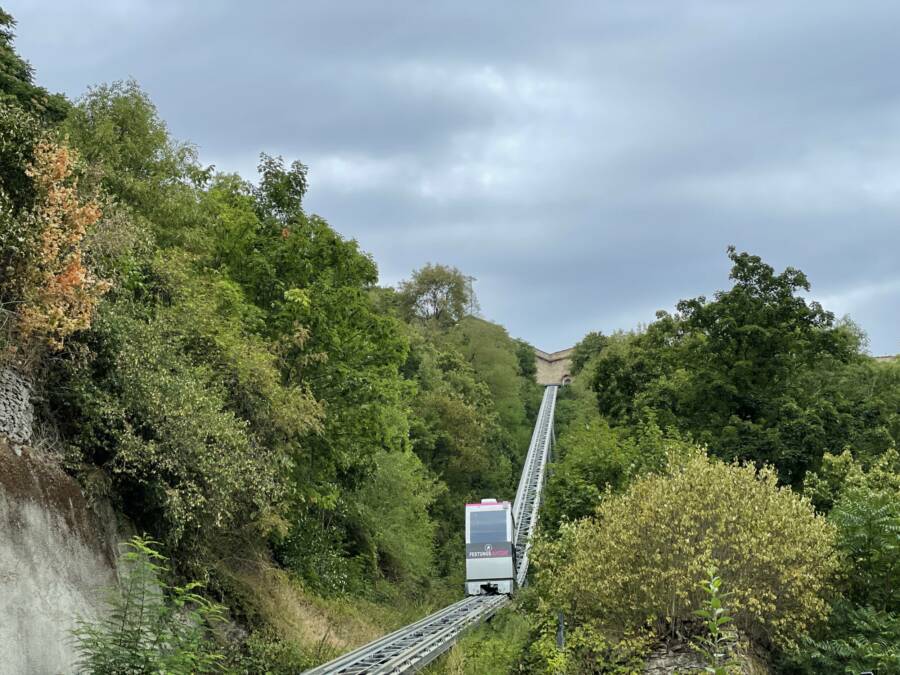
<box><xmin>73</xmin><ymin>537</ymin><xmax>224</xmax><ymax>675</ymax></box>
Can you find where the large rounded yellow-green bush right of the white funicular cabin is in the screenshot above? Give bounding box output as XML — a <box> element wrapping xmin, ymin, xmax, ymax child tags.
<box><xmin>535</xmin><ymin>450</ymin><xmax>837</xmax><ymax>645</ymax></box>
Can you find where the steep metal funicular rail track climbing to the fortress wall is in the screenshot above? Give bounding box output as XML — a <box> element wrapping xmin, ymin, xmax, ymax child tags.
<box><xmin>305</xmin><ymin>386</ymin><xmax>558</xmax><ymax>675</ymax></box>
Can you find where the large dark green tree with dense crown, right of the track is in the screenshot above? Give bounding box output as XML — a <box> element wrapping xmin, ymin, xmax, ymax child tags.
<box><xmin>592</xmin><ymin>248</ymin><xmax>898</xmax><ymax>485</ymax></box>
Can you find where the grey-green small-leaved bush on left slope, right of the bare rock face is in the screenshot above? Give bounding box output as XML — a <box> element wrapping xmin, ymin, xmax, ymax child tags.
<box><xmin>61</xmin><ymin>294</ymin><xmax>285</xmax><ymax>551</ymax></box>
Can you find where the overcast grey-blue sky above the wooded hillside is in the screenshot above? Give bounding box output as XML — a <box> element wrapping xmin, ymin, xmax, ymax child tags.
<box><xmin>3</xmin><ymin>0</ymin><xmax>900</xmax><ymax>354</ymax></box>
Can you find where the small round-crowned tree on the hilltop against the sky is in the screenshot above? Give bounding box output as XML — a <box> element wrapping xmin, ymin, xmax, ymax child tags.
<box><xmin>398</xmin><ymin>263</ymin><xmax>478</xmax><ymax>328</ymax></box>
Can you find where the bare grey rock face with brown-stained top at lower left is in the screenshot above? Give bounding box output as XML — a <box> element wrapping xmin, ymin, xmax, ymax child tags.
<box><xmin>0</xmin><ymin>372</ymin><xmax>116</xmax><ymax>675</ymax></box>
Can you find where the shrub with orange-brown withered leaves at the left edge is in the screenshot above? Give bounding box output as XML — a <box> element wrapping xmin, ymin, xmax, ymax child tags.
<box><xmin>0</xmin><ymin>106</ymin><xmax>108</xmax><ymax>365</ymax></box>
